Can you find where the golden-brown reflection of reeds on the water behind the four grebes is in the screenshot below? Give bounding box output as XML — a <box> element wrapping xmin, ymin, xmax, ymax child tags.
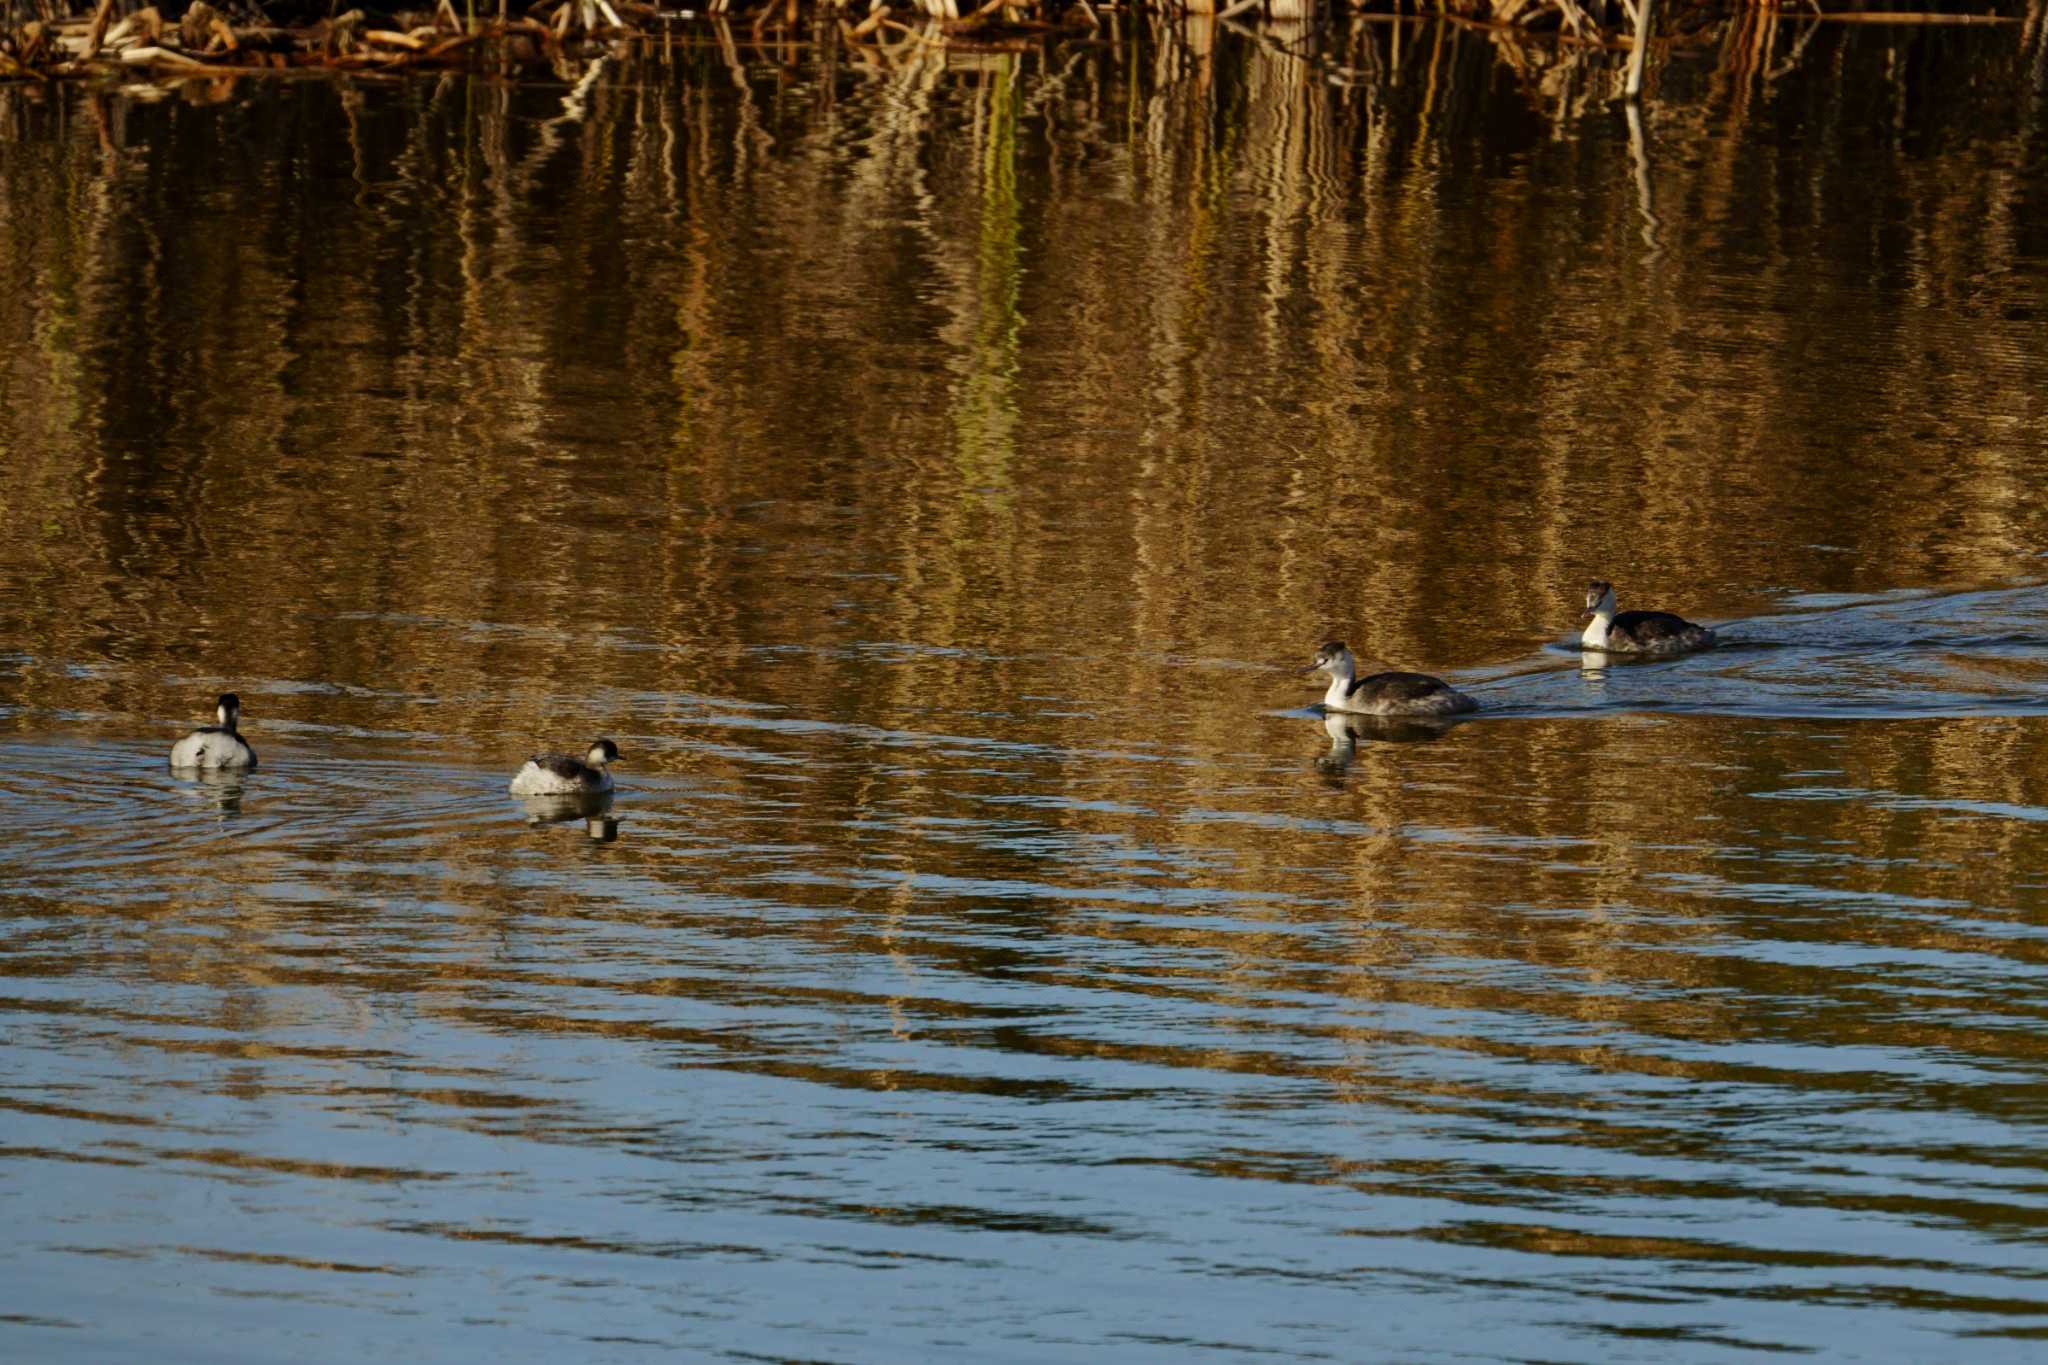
<box><xmin>0</xmin><ymin>16</ymin><xmax>2040</xmax><ymax>749</ymax></box>
